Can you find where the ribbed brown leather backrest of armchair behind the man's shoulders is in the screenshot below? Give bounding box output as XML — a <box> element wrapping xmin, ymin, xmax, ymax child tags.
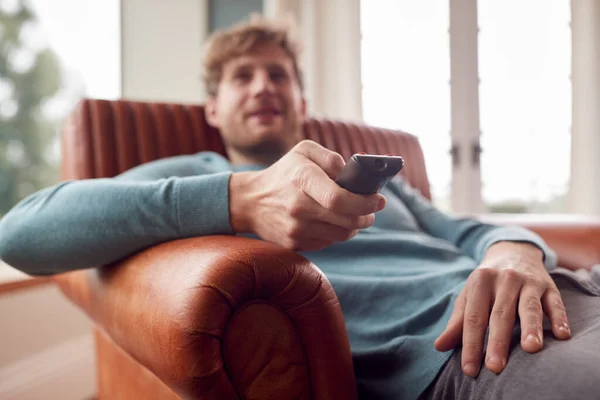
<box><xmin>61</xmin><ymin>99</ymin><xmax>431</xmax><ymax>198</ymax></box>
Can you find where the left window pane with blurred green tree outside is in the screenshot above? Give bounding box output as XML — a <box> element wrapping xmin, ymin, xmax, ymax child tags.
<box><xmin>0</xmin><ymin>0</ymin><xmax>120</xmax><ymax>216</ymax></box>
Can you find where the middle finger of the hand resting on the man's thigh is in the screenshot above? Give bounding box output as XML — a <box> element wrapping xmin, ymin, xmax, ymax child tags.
<box><xmin>485</xmin><ymin>269</ymin><xmax>522</xmax><ymax>374</ymax></box>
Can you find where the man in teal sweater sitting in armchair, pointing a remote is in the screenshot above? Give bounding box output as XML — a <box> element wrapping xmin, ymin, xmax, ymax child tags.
<box><xmin>0</xmin><ymin>16</ymin><xmax>600</xmax><ymax>399</ymax></box>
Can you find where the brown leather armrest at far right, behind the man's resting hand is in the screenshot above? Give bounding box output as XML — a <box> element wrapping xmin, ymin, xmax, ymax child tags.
<box><xmin>476</xmin><ymin>214</ymin><xmax>600</xmax><ymax>270</ymax></box>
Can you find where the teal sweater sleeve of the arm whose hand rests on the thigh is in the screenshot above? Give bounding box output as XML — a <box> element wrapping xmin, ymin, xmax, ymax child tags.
<box><xmin>389</xmin><ymin>178</ymin><xmax>557</xmax><ymax>270</ymax></box>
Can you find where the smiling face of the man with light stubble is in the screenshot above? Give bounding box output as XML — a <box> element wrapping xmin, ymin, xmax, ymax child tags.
<box><xmin>206</xmin><ymin>46</ymin><xmax>306</xmax><ymax>161</ymax></box>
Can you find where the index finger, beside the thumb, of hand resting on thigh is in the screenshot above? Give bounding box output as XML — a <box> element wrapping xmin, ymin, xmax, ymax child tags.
<box><xmin>462</xmin><ymin>268</ymin><xmax>496</xmax><ymax>377</ymax></box>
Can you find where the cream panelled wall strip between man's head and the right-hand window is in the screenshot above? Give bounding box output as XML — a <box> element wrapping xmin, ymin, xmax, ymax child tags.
<box><xmin>264</xmin><ymin>0</ymin><xmax>363</xmax><ymax>122</ymax></box>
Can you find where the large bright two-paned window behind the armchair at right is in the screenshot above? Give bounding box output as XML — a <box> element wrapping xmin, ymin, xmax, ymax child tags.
<box><xmin>361</xmin><ymin>0</ymin><xmax>571</xmax><ymax>212</ymax></box>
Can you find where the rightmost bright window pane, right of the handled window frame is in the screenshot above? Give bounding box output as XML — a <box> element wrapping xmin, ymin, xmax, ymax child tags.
<box><xmin>478</xmin><ymin>0</ymin><xmax>571</xmax><ymax>212</ymax></box>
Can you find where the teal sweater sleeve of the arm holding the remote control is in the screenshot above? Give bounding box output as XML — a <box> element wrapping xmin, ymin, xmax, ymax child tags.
<box><xmin>0</xmin><ymin>152</ymin><xmax>232</xmax><ymax>275</ymax></box>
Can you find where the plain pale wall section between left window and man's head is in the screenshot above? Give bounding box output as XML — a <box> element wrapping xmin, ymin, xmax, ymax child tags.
<box><xmin>121</xmin><ymin>0</ymin><xmax>208</xmax><ymax>103</ymax></box>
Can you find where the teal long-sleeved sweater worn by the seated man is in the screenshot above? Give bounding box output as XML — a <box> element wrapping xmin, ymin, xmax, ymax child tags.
<box><xmin>0</xmin><ymin>153</ymin><xmax>556</xmax><ymax>399</ymax></box>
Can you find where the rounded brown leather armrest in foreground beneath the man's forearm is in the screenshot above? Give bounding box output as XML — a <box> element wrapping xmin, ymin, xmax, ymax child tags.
<box><xmin>57</xmin><ymin>236</ymin><xmax>357</xmax><ymax>399</ymax></box>
